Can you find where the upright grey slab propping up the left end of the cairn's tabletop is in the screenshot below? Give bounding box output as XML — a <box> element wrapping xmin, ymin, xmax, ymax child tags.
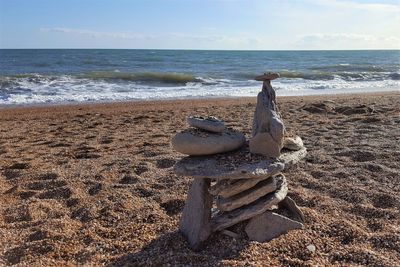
<box><xmin>179</xmin><ymin>179</ymin><xmax>213</xmax><ymax>250</ymax></box>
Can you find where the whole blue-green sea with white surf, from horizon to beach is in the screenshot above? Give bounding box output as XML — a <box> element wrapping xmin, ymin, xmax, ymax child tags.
<box><xmin>0</xmin><ymin>49</ymin><xmax>400</xmax><ymax>105</ymax></box>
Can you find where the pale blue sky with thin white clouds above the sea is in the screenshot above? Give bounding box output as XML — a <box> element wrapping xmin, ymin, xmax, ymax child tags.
<box><xmin>0</xmin><ymin>0</ymin><xmax>400</xmax><ymax>50</ymax></box>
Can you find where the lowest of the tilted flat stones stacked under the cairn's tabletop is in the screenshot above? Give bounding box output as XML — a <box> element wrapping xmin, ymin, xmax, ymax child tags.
<box><xmin>211</xmin><ymin>174</ymin><xmax>288</xmax><ymax>232</ymax></box>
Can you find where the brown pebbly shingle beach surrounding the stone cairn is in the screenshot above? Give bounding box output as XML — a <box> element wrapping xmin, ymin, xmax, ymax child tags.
<box><xmin>0</xmin><ymin>92</ymin><xmax>400</xmax><ymax>266</ymax></box>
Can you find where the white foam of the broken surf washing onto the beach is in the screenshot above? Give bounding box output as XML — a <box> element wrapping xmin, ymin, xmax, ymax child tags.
<box><xmin>0</xmin><ymin>75</ymin><xmax>400</xmax><ymax>105</ymax></box>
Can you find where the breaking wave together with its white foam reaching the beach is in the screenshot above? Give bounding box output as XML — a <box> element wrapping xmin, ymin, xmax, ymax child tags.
<box><xmin>0</xmin><ymin>71</ymin><xmax>400</xmax><ymax>104</ymax></box>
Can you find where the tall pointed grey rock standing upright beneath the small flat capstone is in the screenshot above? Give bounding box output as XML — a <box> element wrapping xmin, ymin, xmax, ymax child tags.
<box><xmin>249</xmin><ymin>80</ymin><xmax>285</xmax><ymax>158</ymax></box>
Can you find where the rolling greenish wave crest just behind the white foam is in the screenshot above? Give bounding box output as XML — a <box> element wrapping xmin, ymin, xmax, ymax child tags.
<box><xmin>0</xmin><ymin>70</ymin><xmax>400</xmax><ymax>89</ymax></box>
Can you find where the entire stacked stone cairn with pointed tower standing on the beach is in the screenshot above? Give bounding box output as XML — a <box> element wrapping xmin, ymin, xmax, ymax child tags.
<box><xmin>172</xmin><ymin>73</ymin><xmax>307</xmax><ymax>250</ymax></box>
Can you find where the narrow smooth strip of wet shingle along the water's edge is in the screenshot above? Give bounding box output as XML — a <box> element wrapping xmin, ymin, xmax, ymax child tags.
<box><xmin>0</xmin><ymin>89</ymin><xmax>400</xmax><ymax>112</ymax></box>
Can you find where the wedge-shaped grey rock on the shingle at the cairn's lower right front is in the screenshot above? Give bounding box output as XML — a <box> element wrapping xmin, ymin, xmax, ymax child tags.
<box><xmin>245</xmin><ymin>211</ymin><xmax>303</xmax><ymax>242</ymax></box>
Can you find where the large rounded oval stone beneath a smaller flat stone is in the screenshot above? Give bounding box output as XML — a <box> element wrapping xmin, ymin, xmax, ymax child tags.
<box><xmin>172</xmin><ymin>130</ymin><xmax>246</xmax><ymax>156</ymax></box>
